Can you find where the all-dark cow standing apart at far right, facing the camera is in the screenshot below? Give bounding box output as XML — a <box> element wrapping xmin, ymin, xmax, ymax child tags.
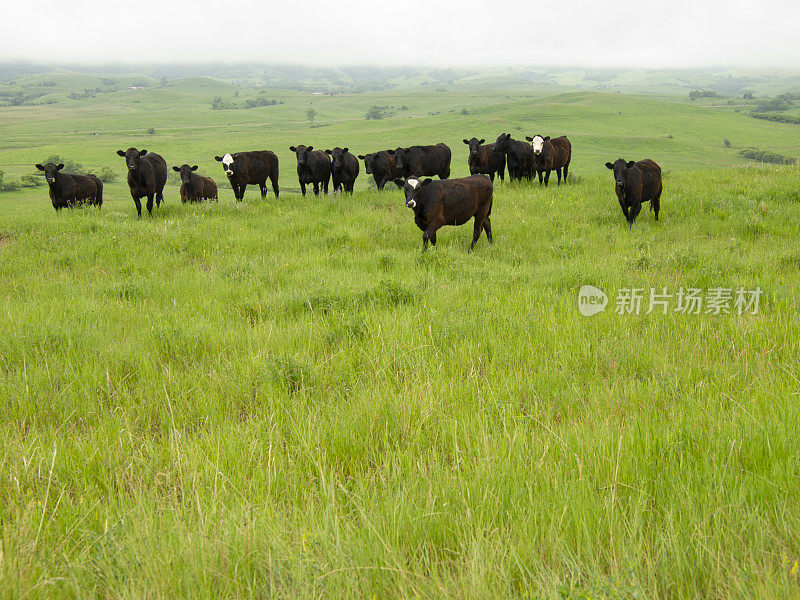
<box><xmin>606</xmin><ymin>158</ymin><xmax>662</xmax><ymax>228</ymax></box>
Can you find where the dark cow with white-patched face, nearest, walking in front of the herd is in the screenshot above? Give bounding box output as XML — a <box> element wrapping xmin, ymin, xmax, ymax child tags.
<box><xmin>394</xmin><ymin>175</ymin><xmax>492</xmax><ymax>251</ymax></box>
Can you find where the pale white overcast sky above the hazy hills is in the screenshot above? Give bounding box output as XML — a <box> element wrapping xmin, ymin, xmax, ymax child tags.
<box><xmin>0</xmin><ymin>0</ymin><xmax>800</xmax><ymax>68</ymax></box>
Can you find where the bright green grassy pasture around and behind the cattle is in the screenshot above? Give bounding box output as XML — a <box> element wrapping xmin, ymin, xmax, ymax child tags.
<box><xmin>0</xmin><ymin>72</ymin><xmax>800</xmax><ymax>600</ymax></box>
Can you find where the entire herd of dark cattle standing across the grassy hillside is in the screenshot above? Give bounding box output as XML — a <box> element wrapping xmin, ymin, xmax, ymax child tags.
<box><xmin>31</xmin><ymin>133</ymin><xmax>662</xmax><ymax>250</ymax></box>
